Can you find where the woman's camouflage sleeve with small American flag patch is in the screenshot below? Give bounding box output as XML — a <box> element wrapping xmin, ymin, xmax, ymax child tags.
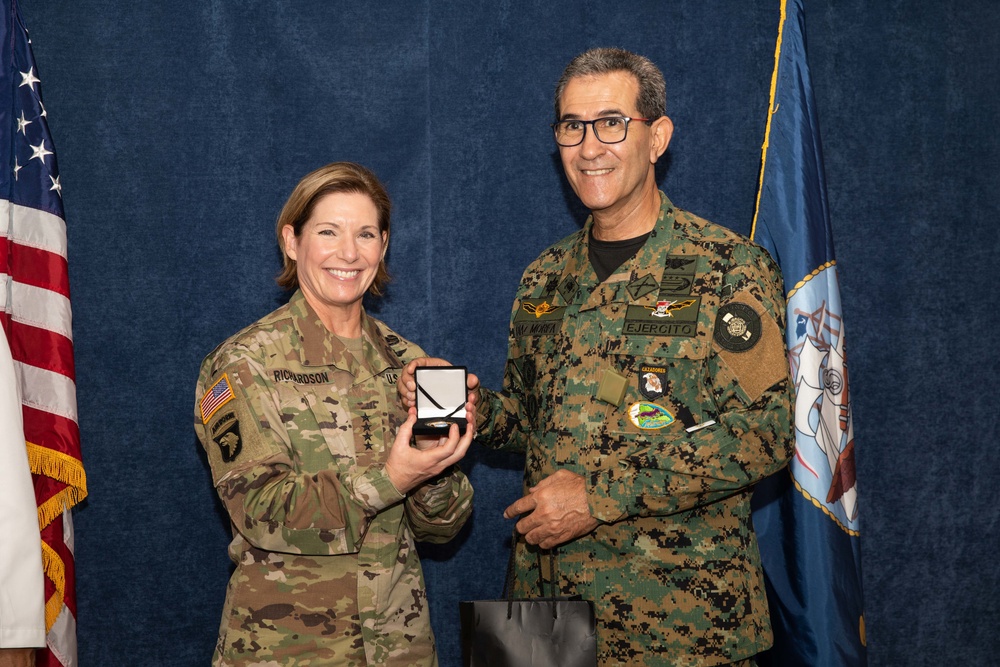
<box><xmin>195</xmin><ymin>349</ymin><xmax>403</xmax><ymax>555</ymax></box>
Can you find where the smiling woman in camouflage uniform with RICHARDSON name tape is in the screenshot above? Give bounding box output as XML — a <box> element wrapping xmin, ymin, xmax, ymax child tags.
<box><xmin>195</xmin><ymin>163</ymin><xmax>475</xmax><ymax>667</ymax></box>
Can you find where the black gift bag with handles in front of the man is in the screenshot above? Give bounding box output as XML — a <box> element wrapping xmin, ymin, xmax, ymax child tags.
<box><xmin>458</xmin><ymin>544</ymin><xmax>597</xmax><ymax>667</ymax></box>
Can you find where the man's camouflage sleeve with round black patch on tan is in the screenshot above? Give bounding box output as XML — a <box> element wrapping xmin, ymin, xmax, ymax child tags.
<box><xmin>588</xmin><ymin>246</ymin><xmax>795</xmax><ymax>522</ymax></box>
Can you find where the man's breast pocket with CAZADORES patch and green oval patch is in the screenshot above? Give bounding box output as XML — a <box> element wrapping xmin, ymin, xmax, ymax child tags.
<box><xmin>606</xmin><ymin>337</ymin><xmax>715</xmax><ymax>437</ymax></box>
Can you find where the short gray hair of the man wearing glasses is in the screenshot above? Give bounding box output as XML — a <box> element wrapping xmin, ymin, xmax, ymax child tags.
<box><xmin>555</xmin><ymin>48</ymin><xmax>667</xmax><ymax>120</ymax></box>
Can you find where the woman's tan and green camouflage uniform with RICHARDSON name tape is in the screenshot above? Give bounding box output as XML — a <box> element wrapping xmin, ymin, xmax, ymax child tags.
<box><xmin>195</xmin><ymin>292</ymin><xmax>472</xmax><ymax>667</ymax></box>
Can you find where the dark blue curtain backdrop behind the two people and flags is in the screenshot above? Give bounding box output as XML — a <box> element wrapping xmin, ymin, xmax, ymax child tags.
<box><xmin>15</xmin><ymin>0</ymin><xmax>1000</xmax><ymax>667</ymax></box>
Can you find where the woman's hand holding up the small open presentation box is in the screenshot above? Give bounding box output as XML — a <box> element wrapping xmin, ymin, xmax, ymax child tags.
<box><xmin>385</xmin><ymin>406</ymin><xmax>476</xmax><ymax>494</ymax></box>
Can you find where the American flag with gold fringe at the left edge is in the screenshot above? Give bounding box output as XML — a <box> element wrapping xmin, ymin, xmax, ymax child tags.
<box><xmin>0</xmin><ymin>0</ymin><xmax>87</xmax><ymax>667</ymax></box>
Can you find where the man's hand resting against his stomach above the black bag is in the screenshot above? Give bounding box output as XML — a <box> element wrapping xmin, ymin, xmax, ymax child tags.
<box><xmin>503</xmin><ymin>470</ymin><xmax>600</xmax><ymax>549</ymax></box>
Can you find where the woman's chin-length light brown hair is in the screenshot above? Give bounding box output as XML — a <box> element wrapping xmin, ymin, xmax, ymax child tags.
<box><xmin>275</xmin><ymin>162</ymin><xmax>392</xmax><ymax>296</ymax></box>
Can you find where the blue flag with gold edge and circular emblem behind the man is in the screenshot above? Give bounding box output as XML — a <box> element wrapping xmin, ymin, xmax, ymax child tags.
<box><xmin>751</xmin><ymin>0</ymin><xmax>868</xmax><ymax>667</ymax></box>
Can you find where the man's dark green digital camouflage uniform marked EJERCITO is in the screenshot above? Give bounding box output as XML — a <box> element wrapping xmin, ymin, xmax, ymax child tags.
<box><xmin>479</xmin><ymin>193</ymin><xmax>794</xmax><ymax>666</ymax></box>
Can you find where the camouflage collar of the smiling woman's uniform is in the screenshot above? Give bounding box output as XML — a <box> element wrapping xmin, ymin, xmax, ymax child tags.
<box><xmin>288</xmin><ymin>290</ymin><xmax>403</xmax><ymax>381</ymax></box>
